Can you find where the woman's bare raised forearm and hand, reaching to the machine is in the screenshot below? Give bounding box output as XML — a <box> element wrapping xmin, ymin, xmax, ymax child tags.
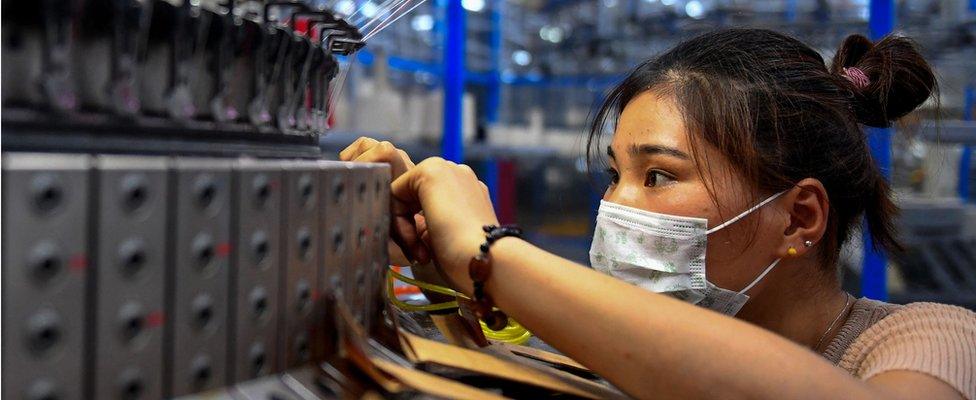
<box><xmin>392</xmin><ymin>159</ymin><xmax>889</xmax><ymax>399</ymax></box>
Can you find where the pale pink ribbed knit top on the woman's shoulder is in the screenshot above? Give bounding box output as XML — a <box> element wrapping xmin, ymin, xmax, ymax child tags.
<box><xmin>823</xmin><ymin>298</ymin><xmax>976</xmax><ymax>400</ymax></box>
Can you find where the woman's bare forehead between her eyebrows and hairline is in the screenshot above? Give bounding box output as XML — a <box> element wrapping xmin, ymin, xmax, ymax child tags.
<box><xmin>611</xmin><ymin>91</ymin><xmax>691</xmax><ymax>153</ymax></box>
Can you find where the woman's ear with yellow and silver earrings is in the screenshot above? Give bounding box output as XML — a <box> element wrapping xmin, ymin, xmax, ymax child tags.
<box><xmin>778</xmin><ymin>178</ymin><xmax>830</xmax><ymax>258</ymax></box>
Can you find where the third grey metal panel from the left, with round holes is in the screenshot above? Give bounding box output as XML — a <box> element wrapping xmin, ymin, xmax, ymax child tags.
<box><xmin>166</xmin><ymin>158</ymin><xmax>232</xmax><ymax>396</ymax></box>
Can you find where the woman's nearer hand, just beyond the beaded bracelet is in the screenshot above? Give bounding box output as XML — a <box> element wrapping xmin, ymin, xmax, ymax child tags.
<box><xmin>390</xmin><ymin>157</ymin><xmax>498</xmax><ymax>294</ymax></box>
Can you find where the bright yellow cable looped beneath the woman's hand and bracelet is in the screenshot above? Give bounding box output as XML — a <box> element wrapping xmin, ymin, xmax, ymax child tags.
<box><xmin>386</xmin><ymin>268</ymin><xmax>532</xmax><ymax>344</ymax></box>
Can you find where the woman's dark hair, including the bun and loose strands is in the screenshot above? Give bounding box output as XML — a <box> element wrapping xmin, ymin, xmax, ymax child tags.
<box><xmin>587</xmin><ymin>29</ymin><xmax>937</xmax><ymax>266</ymax></box>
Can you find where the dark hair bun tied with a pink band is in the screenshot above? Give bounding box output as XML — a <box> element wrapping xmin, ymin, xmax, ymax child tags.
<box><xmin>830</xmin><ymin>34</ymin><xmax>937</xmax><ymax>127</ymax></box>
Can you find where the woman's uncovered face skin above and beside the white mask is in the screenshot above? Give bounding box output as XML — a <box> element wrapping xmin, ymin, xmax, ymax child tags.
<box><xmin>603</xmin><ymin>92</ymin><xmax>789</xmax><ymax>290</ymax></box>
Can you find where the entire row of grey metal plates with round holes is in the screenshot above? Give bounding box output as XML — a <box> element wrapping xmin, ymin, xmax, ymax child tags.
<box><xmin>2</xmin><ymin>153</ymin><xmax>390</xmax><ymax>399</ymax></box>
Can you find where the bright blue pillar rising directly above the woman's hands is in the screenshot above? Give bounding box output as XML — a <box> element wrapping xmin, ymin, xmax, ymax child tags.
<box><xmin>441</xmin><ymin>0</ymin><xmax>465</xmax><ymax>162</ymax></box>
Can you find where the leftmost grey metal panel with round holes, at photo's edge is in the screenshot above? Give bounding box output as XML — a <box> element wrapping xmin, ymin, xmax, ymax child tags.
<box><xmin>0</xmin><ymin>153</ymin><xmax>90</xmax><ymax>399</ymax></box>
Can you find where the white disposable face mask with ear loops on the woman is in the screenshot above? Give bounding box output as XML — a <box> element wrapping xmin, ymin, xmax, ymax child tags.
<box><xmin>590</xmin><ymin>192</ymin><xmax>785</xmax><ymax>315</ymax></box>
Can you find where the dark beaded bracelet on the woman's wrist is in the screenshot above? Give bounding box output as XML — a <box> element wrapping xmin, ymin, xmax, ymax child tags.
<box><xmin>468</xmin><ymin>225</ymin><xmax>522</xmax><ymax>331</ymax></box>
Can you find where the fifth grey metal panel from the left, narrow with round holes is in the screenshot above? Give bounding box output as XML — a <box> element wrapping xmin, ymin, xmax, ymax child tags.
<box><xmin>279</xmin><ymin>161</ymin><xmax>320</xmax><ymax>368</ymax></box>
